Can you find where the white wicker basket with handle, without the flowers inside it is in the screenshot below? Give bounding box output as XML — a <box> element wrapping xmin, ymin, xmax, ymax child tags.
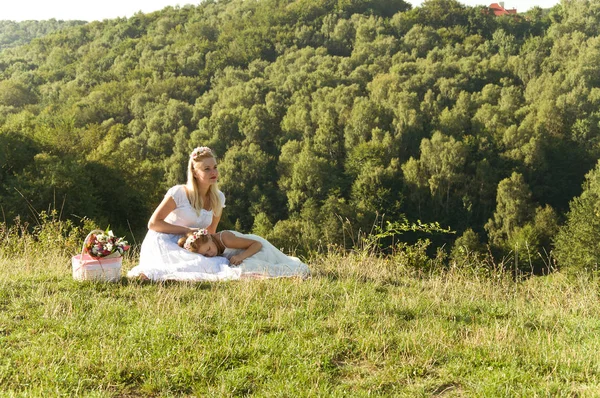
<box><xmin>71</xmin><ymin>229</ymin><xmax>123</xmax><ymax>282</ymax></box>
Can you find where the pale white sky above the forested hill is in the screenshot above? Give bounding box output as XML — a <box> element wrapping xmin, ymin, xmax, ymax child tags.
<box><xmin>0</xmin><ymin>0</ymin><xmax>560</xmax><ymax>22</ymax></box>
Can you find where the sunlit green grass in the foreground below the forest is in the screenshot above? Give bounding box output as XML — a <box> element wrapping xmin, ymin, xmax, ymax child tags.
<box><xmin>0</xmin><ymin>253</ymin><xmax>600</xmax><ymax>397</ymax></box>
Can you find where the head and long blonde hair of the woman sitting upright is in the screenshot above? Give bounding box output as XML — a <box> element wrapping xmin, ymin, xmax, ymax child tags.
<box><xmin>187</xmin><ymin>146</ymin><xmax>223</xmax><ymax>216</ymax></box>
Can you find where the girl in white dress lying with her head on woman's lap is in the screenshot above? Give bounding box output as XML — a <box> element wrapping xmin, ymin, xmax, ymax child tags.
<box><xmin>178</xmin><ymin>229</ymin><xmax>310</xmax><ymax>278</ymax></box>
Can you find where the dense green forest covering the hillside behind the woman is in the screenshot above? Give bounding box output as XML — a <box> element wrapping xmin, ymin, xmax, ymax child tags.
<box><xmin>0</xmin><ymin>0</ymin><xmax>600</xmax><ymax>270</ymax></box>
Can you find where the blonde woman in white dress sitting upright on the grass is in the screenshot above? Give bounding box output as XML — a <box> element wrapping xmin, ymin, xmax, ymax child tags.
<box><xmin>127</xmin><ymin>147</ymin><xmax>241</xmax><ymax>281</ymax></box>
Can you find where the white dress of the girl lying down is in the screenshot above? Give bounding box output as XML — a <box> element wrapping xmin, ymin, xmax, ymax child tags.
<box><xmin>217</xmin><ymin>231</ymin><xmax>310</xmax><ymax>278</ymax></box>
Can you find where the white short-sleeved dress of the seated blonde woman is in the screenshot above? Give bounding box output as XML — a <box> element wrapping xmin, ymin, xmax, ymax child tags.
<box><xmin>127</xmin><ymin>185</ymin><xmax>242</xmax><ymax>281</ymax></box>
